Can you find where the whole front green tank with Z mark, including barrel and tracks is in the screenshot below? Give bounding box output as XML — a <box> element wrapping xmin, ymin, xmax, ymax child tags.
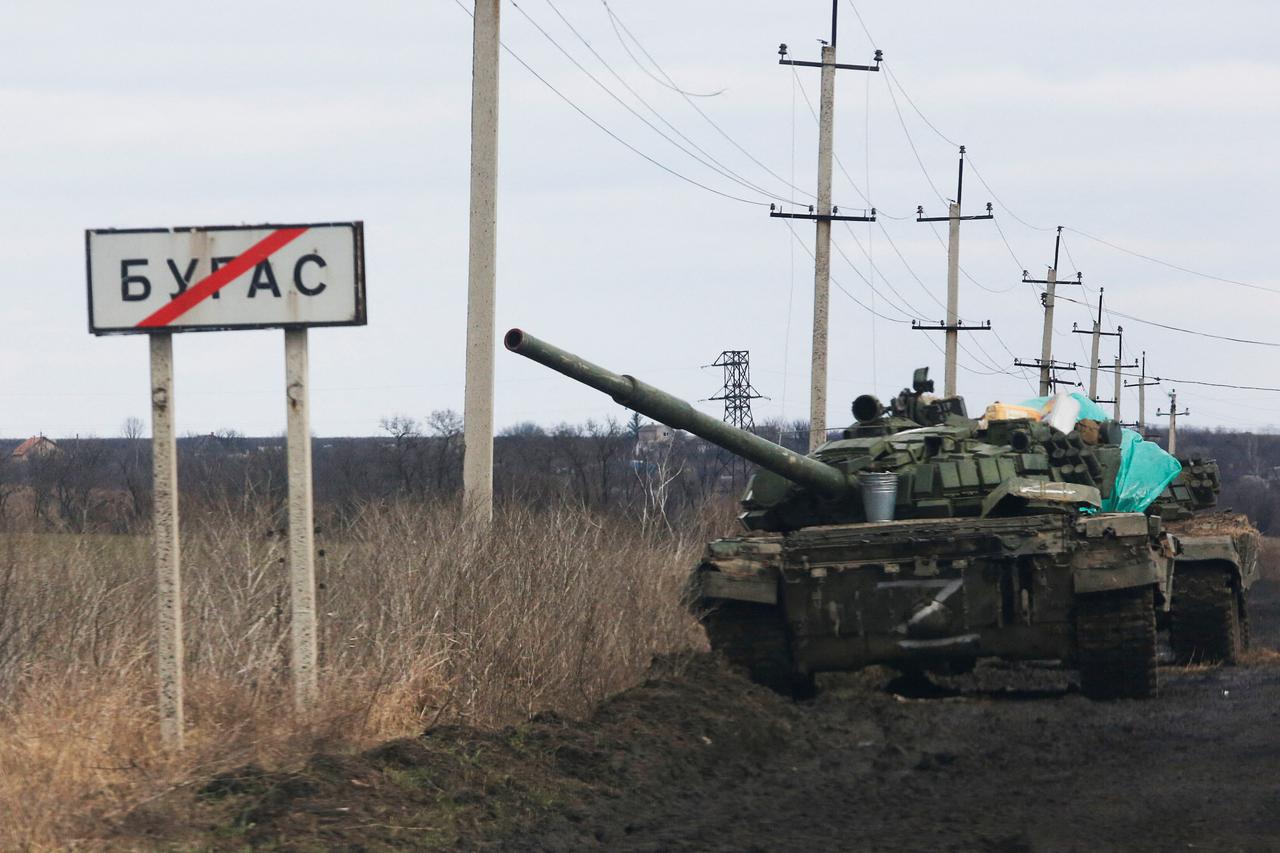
<box><xmin>504</xmin><ymin>329</ymin><xmax>1174</xmax><ymax>699</ymax></box>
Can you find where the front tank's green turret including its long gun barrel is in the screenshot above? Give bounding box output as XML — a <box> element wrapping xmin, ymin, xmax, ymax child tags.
<box><xmin>504</xmin><ymin>329</ymin><xmax>1120</xmax><ymax>532</ymax></box>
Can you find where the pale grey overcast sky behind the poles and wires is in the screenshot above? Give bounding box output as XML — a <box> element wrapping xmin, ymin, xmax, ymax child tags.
<box><xmin>0</xmin><ymin>0</ymin><xmax>1280</xmax><ymax>438</ymax></box>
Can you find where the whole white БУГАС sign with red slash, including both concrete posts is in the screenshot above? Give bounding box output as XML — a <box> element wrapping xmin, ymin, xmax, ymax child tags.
<box><xmin>84</xmin><ymin>222</ymin><xmax>366</xmax><ymax>732</ymax></box>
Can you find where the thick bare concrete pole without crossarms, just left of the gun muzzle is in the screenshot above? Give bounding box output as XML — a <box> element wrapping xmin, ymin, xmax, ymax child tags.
<box><xmin>462</xmin><ymin>0</ymin><xmax>500</xmax><ymax>526</ymax></box>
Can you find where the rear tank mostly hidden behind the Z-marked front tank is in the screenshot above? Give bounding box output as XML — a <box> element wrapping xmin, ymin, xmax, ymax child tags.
<box><xmin>1147</xmin><ymin>457</ymin><xmax>1261</xmax><ymax>665</ymax></box>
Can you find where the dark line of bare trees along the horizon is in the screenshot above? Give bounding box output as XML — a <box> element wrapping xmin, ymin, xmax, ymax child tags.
<box><xmin>0</xmin><ymin>410</ymin><xmax>1280</xmax><ymax>533</ymax></box>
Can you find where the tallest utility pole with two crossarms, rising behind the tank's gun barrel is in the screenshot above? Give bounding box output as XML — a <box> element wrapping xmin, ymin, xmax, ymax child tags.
<box><xmin>769</xmin><ymin>0</ymin><xmax>883</xmax><ymax>451</ymax></box>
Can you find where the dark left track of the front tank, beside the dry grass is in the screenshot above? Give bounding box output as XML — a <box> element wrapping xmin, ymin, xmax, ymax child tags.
<box><xmin>703</xmin><ymin>601</ymin><xmax>814</xmax><ymax>699</ymax></box>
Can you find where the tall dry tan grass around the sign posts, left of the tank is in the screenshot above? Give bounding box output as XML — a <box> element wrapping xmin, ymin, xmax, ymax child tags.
<box><xmin>0</xmin><ymin>505</ymin><xmax>722</xmax><ymax>849</ymax></box>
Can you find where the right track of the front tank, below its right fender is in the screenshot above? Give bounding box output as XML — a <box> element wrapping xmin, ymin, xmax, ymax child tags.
<box><xmin>1075</xmin><ymin>587</ymin><xmax>1156</xmax><ymax>699</ymax></box>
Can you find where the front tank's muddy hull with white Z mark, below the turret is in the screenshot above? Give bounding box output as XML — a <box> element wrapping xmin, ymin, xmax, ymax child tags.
<box><xmin>691</xmin><ymin>514</ymin><xmax>1171</xmax><ymax>696</ymax></box>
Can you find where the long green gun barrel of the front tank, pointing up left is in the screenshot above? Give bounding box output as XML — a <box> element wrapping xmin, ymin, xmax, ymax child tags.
<box><xmin>503</xmin><ymin>329</ymin><xmax>851</xmax><ymax>496</ymax></box>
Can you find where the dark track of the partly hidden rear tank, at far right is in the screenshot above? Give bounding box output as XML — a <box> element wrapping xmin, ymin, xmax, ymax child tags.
<box><xmin>1169</xmin><ymin>565</ymin><xmax>1248</xmax><ymax>666</ymax></box>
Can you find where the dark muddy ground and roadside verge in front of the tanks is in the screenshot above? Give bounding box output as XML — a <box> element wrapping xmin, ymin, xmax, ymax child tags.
<box><xmin>124</xmin><ymin>581</ymin><xmax>1280</xmax><ymax>850</ymax></box>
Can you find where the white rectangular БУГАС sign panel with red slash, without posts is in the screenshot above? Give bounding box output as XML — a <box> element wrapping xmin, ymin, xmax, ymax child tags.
<box><xmin>84</xmin><ymin>222</ymin><xmax>366</xmax><ymax>334</ymax></box>
